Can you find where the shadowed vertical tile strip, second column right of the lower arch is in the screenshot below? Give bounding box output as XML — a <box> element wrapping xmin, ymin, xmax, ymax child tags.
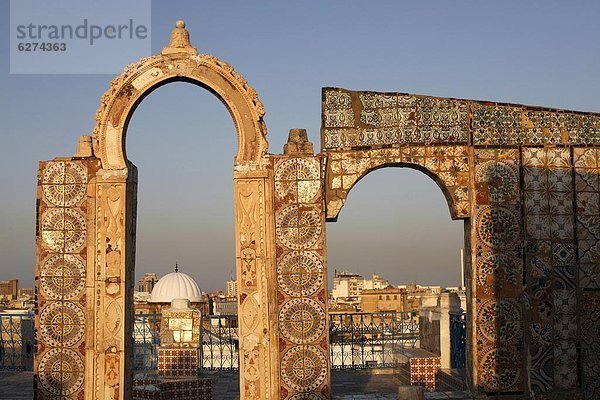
<box><xmin>522</xmin><ymin>147</ymin><xmax>578</xmax><ymax>394</ymax></box>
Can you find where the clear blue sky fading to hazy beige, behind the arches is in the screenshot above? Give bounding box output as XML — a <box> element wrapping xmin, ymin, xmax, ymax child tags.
<box><xmin>0</xmin><ymin>0</ymin><xmax>600</xmax><ymax>290</ymax></box>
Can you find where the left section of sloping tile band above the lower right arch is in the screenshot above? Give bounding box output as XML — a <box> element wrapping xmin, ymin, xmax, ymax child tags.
<box><xmin>323</xmin><ymin>88</ymin><xmax>468</xmax><ymax>149</ymax></box>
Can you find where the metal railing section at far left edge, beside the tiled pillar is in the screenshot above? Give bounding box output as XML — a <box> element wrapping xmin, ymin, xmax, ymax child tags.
<box><xmin>0</xmin><ymin>312</ymin><xmax>35</xmax><ymax>371</ymax></box>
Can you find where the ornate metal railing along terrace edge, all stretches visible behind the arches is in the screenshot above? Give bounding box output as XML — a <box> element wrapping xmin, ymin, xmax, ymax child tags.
<box><xmin>0</xmin><ymin>312</ymin><xmax>419</xmax><ymax>371</ymax></box>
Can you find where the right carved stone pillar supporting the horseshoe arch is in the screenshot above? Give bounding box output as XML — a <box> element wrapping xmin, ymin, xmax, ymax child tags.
<box><xmin>233</xmin><ymin>168</ymin><xmax>279</xmax><ymax>400</ymax></box>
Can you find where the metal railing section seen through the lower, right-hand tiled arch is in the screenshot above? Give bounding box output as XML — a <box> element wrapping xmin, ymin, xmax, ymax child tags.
<box><xmin>329</xmin><ymin>312</ymin><xmax>419</xmax><ymax>369</ymax></box>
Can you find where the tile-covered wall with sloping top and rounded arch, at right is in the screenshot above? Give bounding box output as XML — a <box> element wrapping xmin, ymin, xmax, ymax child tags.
<box><xmin>321</xmin><ymin>88</ymin><xmax>600</xmax><ymax>399</ymax></box>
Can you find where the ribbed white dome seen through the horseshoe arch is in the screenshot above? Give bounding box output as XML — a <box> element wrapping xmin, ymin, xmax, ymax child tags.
<box><xmin>148</xmin><ymin>272</ymin><xmax>202</xmax><ymax>303</ymax></box>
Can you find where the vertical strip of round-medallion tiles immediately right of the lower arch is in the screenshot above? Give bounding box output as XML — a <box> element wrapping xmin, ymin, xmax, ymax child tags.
<box><xmin>472</xmin><ymin>149</ymin><xmax>525</xmax><ymax>392</ymax></box>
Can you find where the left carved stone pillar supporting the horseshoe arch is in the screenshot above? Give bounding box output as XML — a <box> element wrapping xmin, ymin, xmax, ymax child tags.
<box><xmin>88</xmin><ymin>164</ymin><xmax>137</xmax><ymax>399</ymax></box>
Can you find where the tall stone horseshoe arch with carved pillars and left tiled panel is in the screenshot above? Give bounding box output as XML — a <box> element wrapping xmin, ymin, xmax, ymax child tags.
<box><xmin>35</xmin><ymin>21</ymin><xmax>279</xmax><ymax>400</ymax></box>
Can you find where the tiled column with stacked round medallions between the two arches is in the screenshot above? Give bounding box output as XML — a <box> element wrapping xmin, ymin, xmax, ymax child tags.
<box><xmin>274</xmin><ymin>157</ymin><xmax>330</xmax><ymax>400</ymax></box>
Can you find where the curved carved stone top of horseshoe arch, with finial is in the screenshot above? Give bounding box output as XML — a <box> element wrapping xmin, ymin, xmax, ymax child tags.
<box><xmin>93</xmin><ymin>21</ymin><xmax>268</xmax><ymax>170</ymax></box>
